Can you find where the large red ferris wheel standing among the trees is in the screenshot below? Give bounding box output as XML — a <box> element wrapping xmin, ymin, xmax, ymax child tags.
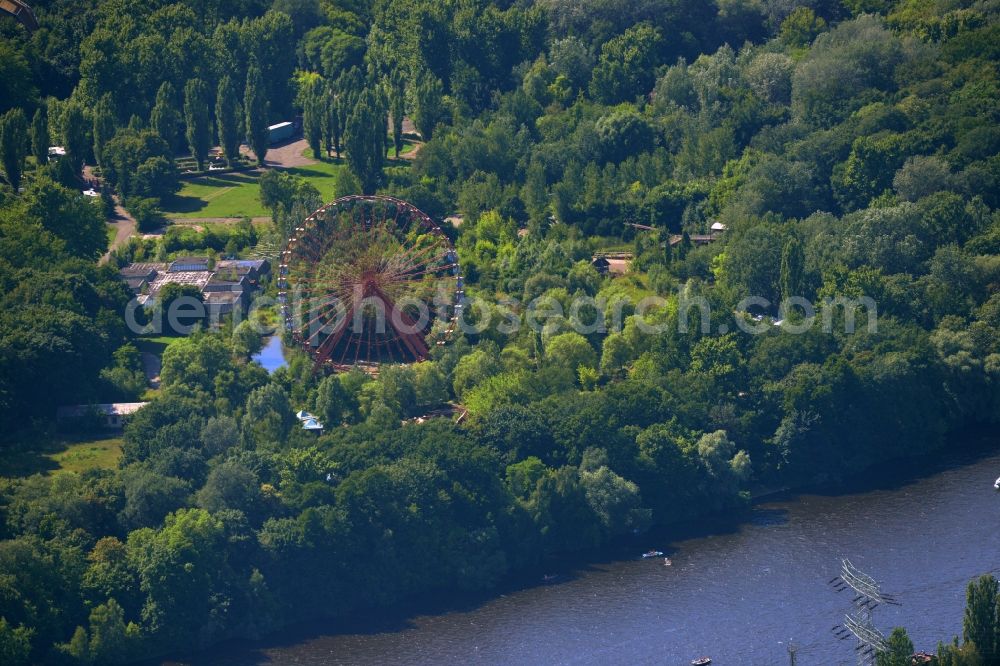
<box><xmin>278</xmin><ymin>196</ymin><xmax>464</xmax><ymax>369</ymax></box>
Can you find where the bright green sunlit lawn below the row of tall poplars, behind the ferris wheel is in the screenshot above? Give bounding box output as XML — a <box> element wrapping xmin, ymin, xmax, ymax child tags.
<box><xmin>163</xmin><ymin>161</ymin><xmax>340</xmax><ymax>218</ymax></box>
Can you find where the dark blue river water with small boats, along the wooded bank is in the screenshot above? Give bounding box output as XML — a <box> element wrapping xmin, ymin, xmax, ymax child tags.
<box><xmin>180</xmin><ymin>446</ymin><xmax>1000</xmax><ymax>666</ymax></box>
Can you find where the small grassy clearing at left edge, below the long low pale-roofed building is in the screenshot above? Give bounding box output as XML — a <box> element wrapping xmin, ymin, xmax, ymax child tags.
<box><xmin>0</xmin><ymin>434</ymin><xmax>122</xmax><ymax>478</ymax></box>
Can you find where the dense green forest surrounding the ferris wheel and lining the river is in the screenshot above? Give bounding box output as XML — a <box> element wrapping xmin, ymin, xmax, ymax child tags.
<box><xmin>0</xmin><ymin>0</ymin><xmax>1000</xmax><ymax>664</ymax></box>
